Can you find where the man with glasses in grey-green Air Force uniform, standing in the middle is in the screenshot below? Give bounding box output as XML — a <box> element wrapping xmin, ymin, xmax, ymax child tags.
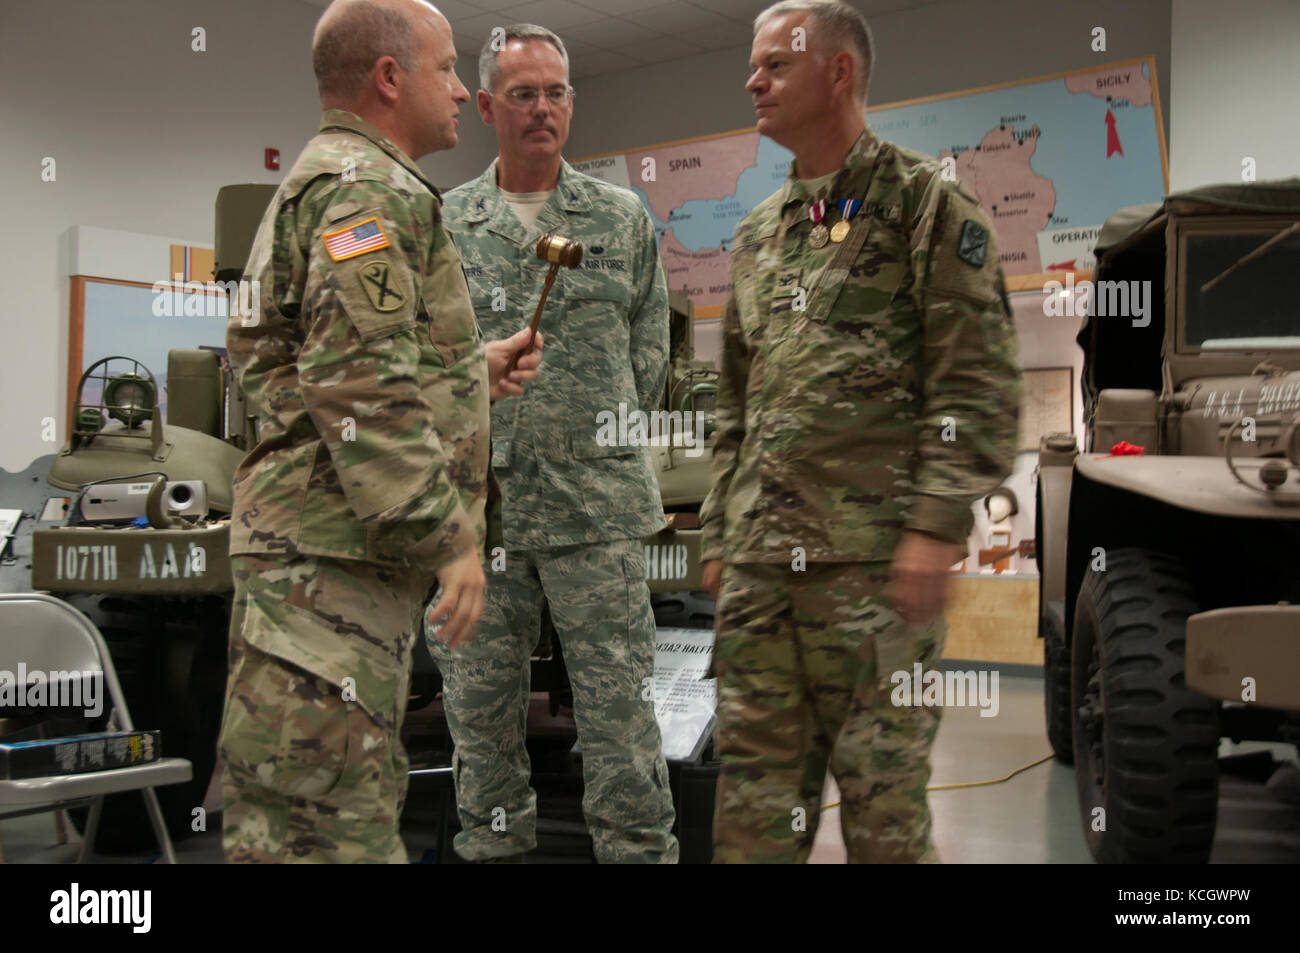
<box><xmin>430</xmin><ymin>26</ymin><xmax>677</xmax><ymax>863</ymax></box>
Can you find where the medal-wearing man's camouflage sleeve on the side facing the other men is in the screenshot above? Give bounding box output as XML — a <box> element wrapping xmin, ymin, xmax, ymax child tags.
<box><xmin>699</xmin><ymin>291</ymin><xmax>749</xmax><ymax>560</ymax></box>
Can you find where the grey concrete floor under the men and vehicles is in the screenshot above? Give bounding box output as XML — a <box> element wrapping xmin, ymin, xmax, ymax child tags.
<box><xmin>0</xmin><ymin>676</ymin><xmax>1300</xmax><ymax>863</ymax></box>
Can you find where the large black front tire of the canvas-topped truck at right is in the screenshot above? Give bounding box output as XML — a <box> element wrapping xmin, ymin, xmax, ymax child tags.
<box><xmin>1071</xmin><ymin>549</ymin><xmax>1219</xmax><ymax>863</ymax></box>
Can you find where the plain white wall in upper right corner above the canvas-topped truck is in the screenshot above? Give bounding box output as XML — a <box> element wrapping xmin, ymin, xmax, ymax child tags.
<box><xmin>1169</xmin><ymin>0</ymin><xmax>1300</xmax><ymax>191</ymax></box>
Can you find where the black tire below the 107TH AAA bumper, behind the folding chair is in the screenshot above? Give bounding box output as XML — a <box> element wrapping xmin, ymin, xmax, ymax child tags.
<box><xmin>66</xmin><ymin>595</ymin><xmax>230</xmax><ymax>854</ymax></box>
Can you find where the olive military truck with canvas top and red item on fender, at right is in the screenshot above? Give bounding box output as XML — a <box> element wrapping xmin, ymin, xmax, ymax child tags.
<box><xmin>1036</xmin><ymin>179</ymin><xmax>1300</xmax><ymax>862</ymax></box>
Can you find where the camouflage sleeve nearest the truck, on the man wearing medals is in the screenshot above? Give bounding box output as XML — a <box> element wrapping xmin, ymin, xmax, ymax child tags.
<box><xmin>906</xmin><ymin>174</ymin><xmax>1021</xmax><ymax>543</ymax></box>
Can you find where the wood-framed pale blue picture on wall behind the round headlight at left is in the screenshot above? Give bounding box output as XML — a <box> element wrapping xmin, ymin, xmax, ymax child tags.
<box><xmin>68</xmin><ymin>274</ymin><xmax>226</xmax><ymax>428</ymax></box>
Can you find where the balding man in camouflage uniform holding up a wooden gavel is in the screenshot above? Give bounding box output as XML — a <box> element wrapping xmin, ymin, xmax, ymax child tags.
<box><xmin>220</xmin><ymin>0</ymin><xmax>536</xmax><ymax>863</ymax></box>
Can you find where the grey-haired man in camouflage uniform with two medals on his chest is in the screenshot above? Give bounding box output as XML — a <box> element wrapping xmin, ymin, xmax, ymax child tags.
<box><xmin>701</xmin><ymin>0</ymin><xmax>1019</xmax><ymax>862</ymax></box>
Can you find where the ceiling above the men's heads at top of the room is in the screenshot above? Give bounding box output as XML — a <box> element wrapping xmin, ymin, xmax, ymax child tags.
<box><xmin>294</xmin><ymin>0</ymin><xmax>935</xmax><ymax>79</ymax></box>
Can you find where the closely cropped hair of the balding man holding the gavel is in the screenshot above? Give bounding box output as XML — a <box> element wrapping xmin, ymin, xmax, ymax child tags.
<box><xmin>312</xmin><ymin>0</ymin><xmax>419</xmax><ymax>101</ymax></box>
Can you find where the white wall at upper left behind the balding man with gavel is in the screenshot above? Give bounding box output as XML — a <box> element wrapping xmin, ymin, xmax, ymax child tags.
<box><xmin>0</xmin><ymin>0</ymin><xmax>494</xmax><ymax>471</ymax></box>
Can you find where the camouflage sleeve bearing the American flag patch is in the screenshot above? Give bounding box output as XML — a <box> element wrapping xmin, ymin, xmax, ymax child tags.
<box><xmin>298</xmin><ymin>182</ymin><xmax>477</xmax><ymax>569</ymax></box>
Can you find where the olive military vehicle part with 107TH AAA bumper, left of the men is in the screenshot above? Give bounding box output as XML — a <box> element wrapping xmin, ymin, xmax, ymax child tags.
<box><xmin>0</xmin><ymin>350</ymin><xmax>244</xmax><ymax>852</ymax></box>
